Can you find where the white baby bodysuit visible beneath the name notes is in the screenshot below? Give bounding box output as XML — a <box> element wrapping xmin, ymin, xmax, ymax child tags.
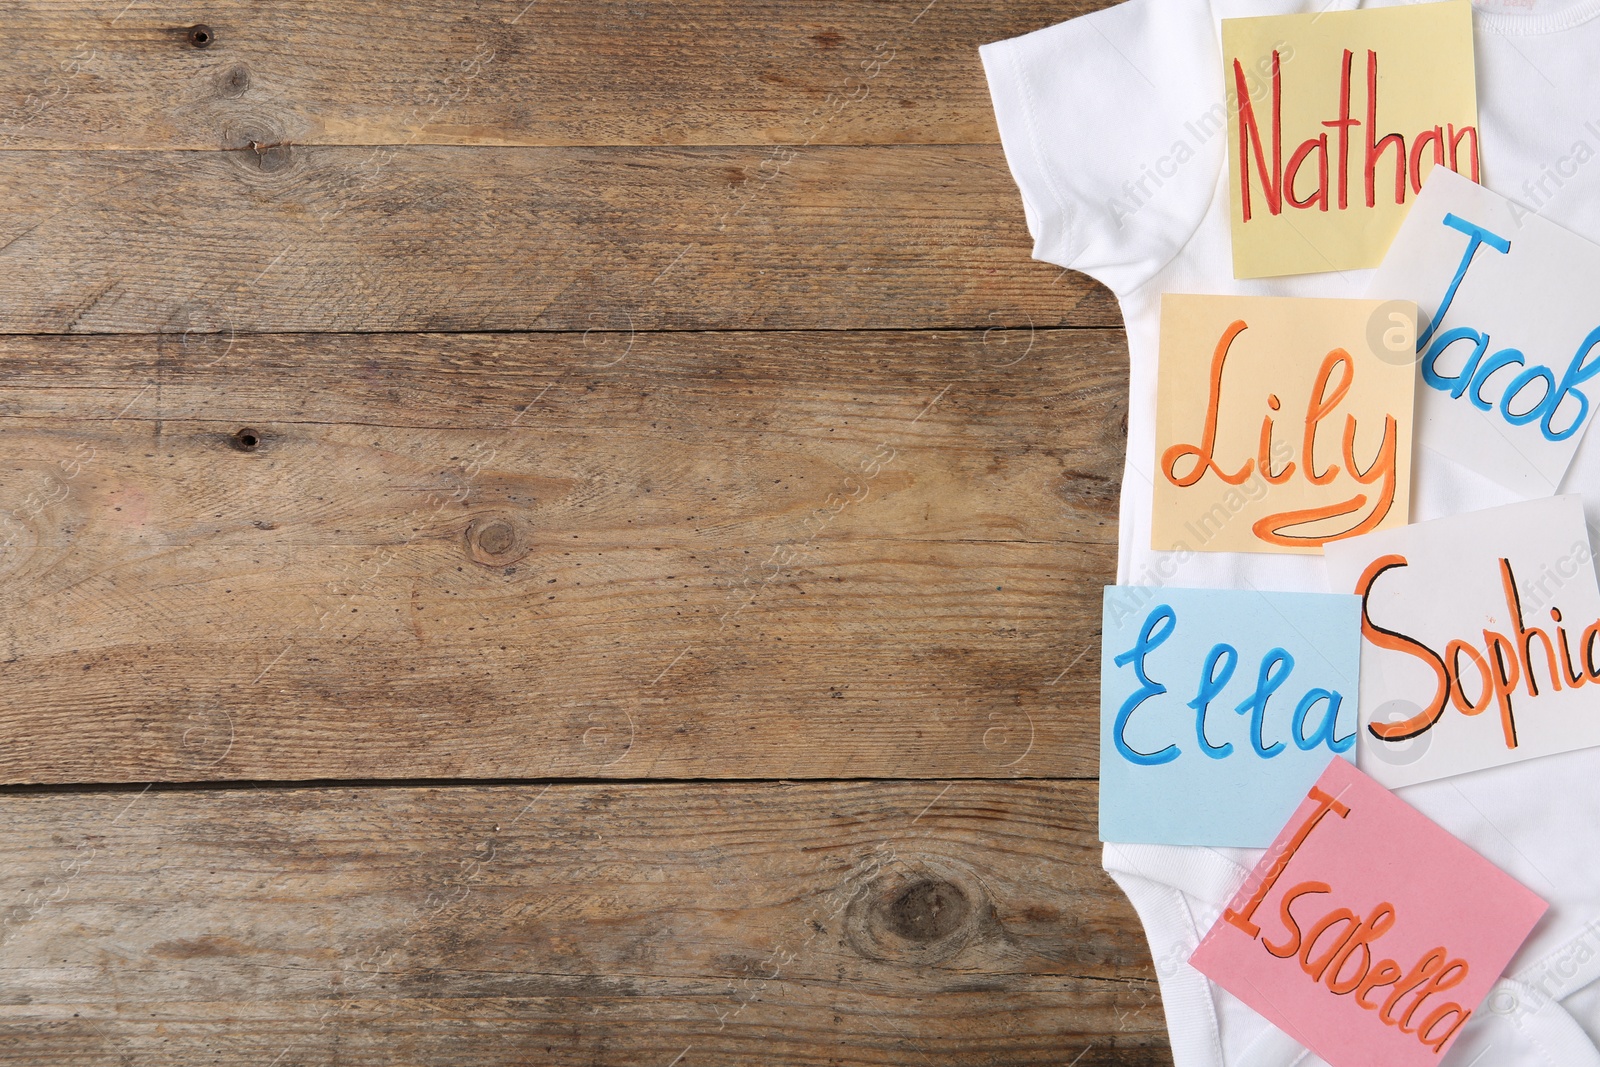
<box><xmin>981</xmin><ymin>0</ymin><xmax>1600</xmax><ymax>1067</ymax></box>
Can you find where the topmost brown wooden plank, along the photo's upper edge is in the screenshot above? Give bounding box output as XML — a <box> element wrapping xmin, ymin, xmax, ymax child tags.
<box><xmin>0</xmin><ymin>0</ymin><xmax>1106</xmax><ymax>150</ymax></box>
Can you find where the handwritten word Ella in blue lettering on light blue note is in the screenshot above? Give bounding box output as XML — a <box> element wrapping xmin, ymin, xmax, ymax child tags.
<box><xmin>1112</xmin><ymin>605</ymin><xmax>1355</xmax><ymax>766</ymax></box>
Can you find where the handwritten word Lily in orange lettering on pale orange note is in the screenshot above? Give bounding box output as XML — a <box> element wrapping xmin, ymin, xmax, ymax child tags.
<box><xmin>1162</xmin><ymin>320</ymin><xmax>1400</xmax><ymax>547</ymax></box>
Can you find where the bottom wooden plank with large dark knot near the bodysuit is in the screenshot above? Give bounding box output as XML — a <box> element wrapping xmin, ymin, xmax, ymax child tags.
<box><xmin>0</xmin><ymin>781</ymin><xmax>1171</xmax><ymax>1067</ymax></box>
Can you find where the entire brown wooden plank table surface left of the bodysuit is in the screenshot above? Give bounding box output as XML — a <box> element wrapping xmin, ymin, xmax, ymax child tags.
<box><xmin>0</xmin><ymin>0</ymin><xmax>1170</xmax><ymax>1067</ymax></box>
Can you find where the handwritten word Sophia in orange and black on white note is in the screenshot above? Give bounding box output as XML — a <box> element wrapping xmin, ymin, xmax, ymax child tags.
<box><xmin>1355</xmin><ymin>555</ymin><xmax>1600</xmax><ymax>749</ymax></box>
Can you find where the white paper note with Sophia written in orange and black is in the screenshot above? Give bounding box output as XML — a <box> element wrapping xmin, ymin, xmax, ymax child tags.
<box><xmin>1328</xmin><ymin>496</ymin><xmax>1600</xmax><ymax>789</ymax></box>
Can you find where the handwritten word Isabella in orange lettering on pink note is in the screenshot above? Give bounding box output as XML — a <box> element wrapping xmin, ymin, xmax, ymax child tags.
<box><xmin>1222</xmin><ymin>785</ymin><xmax>1472</xmax><ymax>1053</ymax></box>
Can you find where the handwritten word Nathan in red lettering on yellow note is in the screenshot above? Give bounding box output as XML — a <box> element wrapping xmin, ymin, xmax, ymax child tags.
<box><xmin>1234</xmin><ymin>48</ymin><xmax>1478</xmax><ymax>222</ymax></box>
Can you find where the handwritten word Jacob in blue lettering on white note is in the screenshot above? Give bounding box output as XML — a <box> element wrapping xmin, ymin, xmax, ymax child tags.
<box><xmin>1416</xmin><ymin>214</ymin><xmax>1600</xmax><ymax>442</ymax></box>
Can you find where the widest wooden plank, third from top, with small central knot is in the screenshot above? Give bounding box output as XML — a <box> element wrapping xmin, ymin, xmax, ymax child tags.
<box><xmin>0</xmin><ymin>330</ymin><xmax>1126</xmax><ymax>782</ymax></box>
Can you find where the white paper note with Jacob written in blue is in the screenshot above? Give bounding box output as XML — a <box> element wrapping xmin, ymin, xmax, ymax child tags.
<box><xmin>1370</xmin><ymin>168</ymin><xmax>1600</xmax><ymax>498</ymax></box>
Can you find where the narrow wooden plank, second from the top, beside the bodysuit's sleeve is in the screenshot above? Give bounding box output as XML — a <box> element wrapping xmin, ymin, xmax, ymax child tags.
<box><xmin>0</xmin><ymin>146</ymin><xmax>1120</xmax><ymax>333</ymax></box>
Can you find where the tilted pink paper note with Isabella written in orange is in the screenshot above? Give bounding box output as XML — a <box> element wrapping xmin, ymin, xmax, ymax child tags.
<box><xmin>1189</xmin><ymin>760</ymin><xmax>1546</xmax><ymax>1067</ymax></box>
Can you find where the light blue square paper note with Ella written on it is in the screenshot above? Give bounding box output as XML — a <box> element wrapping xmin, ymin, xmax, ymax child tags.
<box><xmin>1099</xmin><ymin>585</ymin><xmax>1362</xmax><ymax>848</ymax></box>
